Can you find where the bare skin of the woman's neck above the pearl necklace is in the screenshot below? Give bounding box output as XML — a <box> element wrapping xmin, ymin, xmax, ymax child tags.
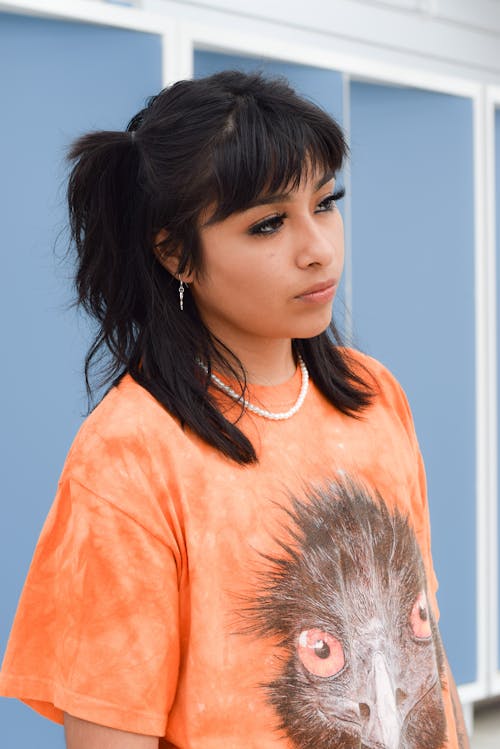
<box><xmin>215</xmin><ymin>339</ymin><xmax>296</xmax><ymax>385</ymax></box>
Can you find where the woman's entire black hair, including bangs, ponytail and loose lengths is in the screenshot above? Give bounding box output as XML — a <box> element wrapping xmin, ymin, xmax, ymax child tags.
<box><xmin>68</xmin><ymin>71</ymin><xmax>372</xmax><ymax>463</ymax></box>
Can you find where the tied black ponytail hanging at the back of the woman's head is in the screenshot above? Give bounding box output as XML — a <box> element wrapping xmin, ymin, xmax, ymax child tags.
<box><xmin>68</xmin><ymin>131</ymin><xmax>150</xmax><ymax>395</ymax></box>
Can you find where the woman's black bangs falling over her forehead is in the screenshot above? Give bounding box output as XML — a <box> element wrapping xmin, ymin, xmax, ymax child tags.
<box><xmin>204</xmin><ymin>92</ymin><xmax>348</xmax><ymax>224</ymax></box>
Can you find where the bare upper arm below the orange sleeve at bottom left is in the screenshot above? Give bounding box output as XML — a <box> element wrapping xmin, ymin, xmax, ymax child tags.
<box><xmin>64</xmin><ymin>713</ymin><xmax>159</xmax><ymax>749</ymax></box>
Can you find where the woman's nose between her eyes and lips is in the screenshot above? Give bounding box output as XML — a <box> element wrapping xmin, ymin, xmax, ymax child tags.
<box><xmin>294</xmin><ymin>215</ymin><xmax>343</xmax><ymax>268</ymax></box>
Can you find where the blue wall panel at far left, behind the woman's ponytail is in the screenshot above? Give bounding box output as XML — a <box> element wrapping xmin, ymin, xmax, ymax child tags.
<box><xmin>0</xmin><ymin>14</ymin><xmax>161</xmax><ymax>749</ymax></box>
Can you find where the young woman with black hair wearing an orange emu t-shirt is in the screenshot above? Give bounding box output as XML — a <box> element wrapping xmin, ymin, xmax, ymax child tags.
<box><xmin>0</xmin><ymin>72</ymin><xmax>467</xmax><ymax>749</ymax></box>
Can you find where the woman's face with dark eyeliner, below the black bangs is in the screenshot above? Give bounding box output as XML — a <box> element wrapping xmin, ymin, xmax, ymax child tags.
<box><xmin>187</xmin><ymin>174</ymin><xmax>344</xmax><ymax>350</ymax></box>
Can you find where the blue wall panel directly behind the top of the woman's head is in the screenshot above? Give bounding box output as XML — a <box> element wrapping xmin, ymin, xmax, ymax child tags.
<box><xmin>194</xmin><ymin>50</ymin><xmax>346</xmax><ymax>331</ymax></box>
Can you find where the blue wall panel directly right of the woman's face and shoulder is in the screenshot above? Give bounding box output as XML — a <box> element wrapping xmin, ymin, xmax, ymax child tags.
<box><xmin>351</xmin><ymin>83</ymin><xmax>477</xmax><ymax>683</ymax></box>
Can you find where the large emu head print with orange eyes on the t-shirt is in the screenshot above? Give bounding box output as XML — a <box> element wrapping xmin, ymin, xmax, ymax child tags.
<box><xmin>243</xmin><ymin>481</ymin><xmax>446</xmax><ymax>749</ymax></box>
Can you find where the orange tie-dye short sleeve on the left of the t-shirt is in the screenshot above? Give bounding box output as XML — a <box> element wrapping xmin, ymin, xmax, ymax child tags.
<box><xmin>0</xmin><ymin>476</ymin><xmax>179</xmax><ymax>736</ymax></box>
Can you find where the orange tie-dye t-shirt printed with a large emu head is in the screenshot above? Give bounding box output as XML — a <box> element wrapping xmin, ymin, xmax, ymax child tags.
<box><xmin>0</xmin><ymin>354</ymin><xmax>457</xmax><ymax>749</ymax></box>
